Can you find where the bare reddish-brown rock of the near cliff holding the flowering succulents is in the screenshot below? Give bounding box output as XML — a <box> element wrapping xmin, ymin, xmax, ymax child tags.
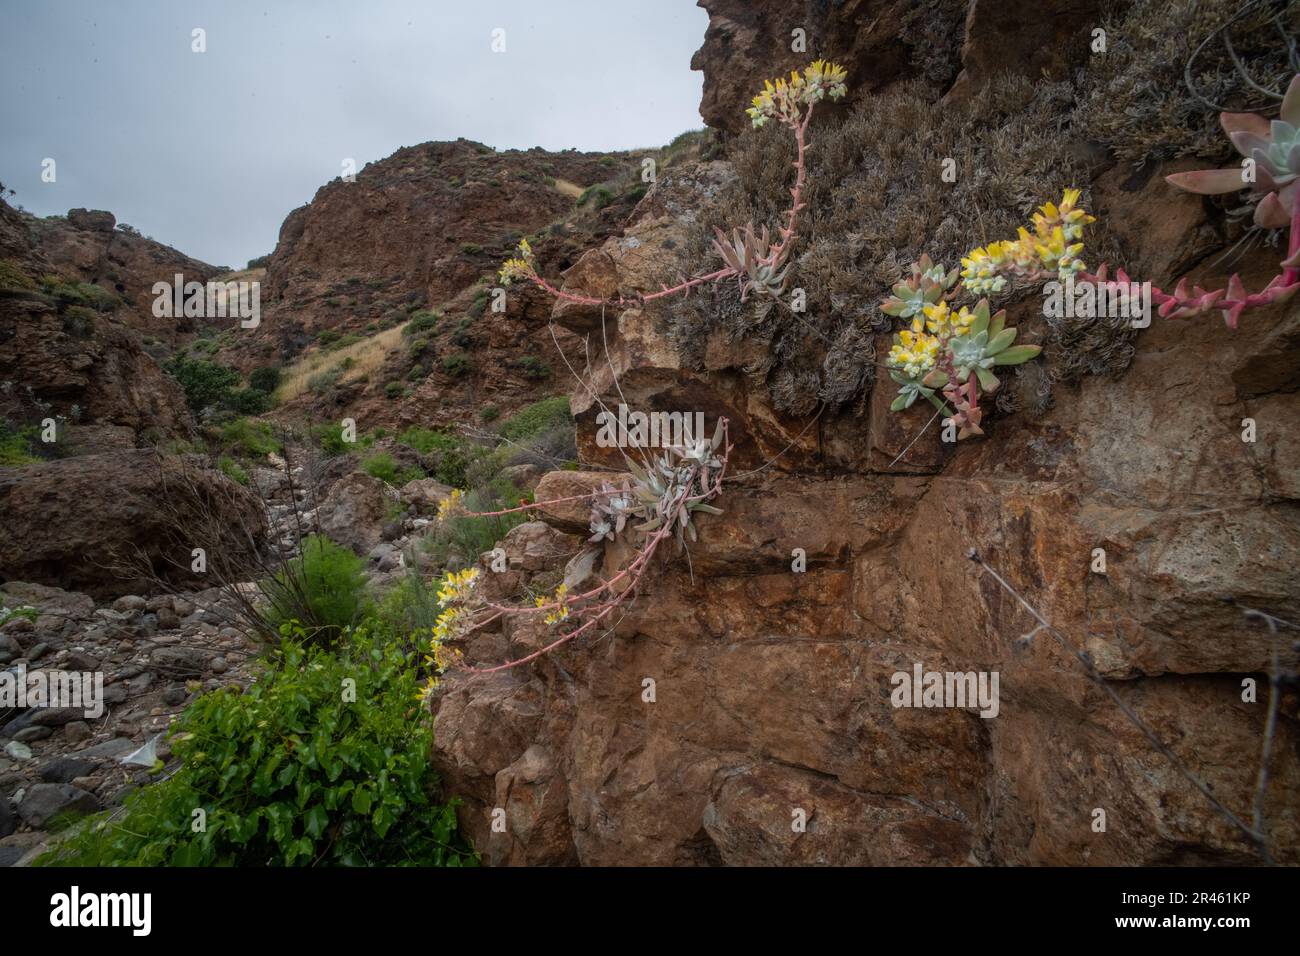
<box><xmin>434</xmin><ymin>1</ymin><xmax>1300</xmax><ymax>865</ymax></box>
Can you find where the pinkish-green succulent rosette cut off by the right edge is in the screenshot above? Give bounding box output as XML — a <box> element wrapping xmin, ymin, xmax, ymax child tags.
<box><xmin>1165</xmin><ymin>75</ymin><xmax>1300</xmax><ymax>229</ymax></box>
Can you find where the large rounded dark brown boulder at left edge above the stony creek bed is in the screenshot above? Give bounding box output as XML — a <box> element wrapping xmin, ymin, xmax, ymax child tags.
<box><xmin>0</xmin><ymin>450</ymin><xmax>265</xmax><ymax>598</ymax></box>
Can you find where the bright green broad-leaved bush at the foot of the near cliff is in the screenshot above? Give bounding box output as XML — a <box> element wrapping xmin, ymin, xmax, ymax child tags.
<box><xmin>38</xmin><ymin>626</ymin><xmax>477</xmax><ymax>866</ymax></box>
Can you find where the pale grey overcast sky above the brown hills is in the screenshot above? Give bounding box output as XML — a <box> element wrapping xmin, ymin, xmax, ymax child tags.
<box><xmin>0</xmin><ymin>0</ymin><xmax>709</xmax><ymax>267</ymax></box>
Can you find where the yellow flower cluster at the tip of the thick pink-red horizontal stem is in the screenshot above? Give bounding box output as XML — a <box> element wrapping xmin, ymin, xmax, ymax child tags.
<box><xmin>962</xmin><ymin>189</ymin><xmax>1097</xmax><ymax>295</ymax></box>
